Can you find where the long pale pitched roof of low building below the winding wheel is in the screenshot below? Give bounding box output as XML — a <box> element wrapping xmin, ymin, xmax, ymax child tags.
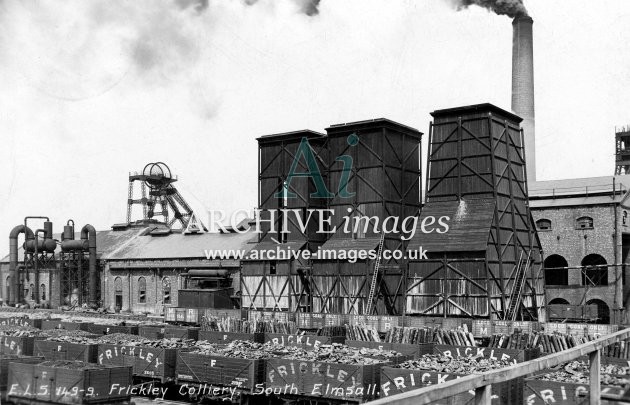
<box><xmin>102</xmin><ymin>232</ymin><xmax>258</xmax><ymax>260</ymax></box>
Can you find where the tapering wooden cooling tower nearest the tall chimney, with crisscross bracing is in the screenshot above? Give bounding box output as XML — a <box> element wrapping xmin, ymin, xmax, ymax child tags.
<box><xmin>406</xmin><ymin>104</ymin><xmax>544</xmax><ymax>319</ymax></box>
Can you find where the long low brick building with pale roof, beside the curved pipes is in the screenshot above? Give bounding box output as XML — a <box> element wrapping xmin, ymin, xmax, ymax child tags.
<box><xmin>0</xmin><ymin>226</ymin><xmax>257</xmax><ymax>314</ymax></box>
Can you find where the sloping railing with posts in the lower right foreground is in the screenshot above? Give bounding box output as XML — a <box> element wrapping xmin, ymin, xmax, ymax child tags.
<box><xmin>370</xmin><ymin>329</ymin><xmax>630</xmax><ymax>405</ymax></box>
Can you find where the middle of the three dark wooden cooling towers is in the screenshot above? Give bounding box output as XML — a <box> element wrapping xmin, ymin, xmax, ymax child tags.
<box><xmin>311</xmin><ymin>118</ymin><xmax>422</xmax><ymax>315</ymax></box>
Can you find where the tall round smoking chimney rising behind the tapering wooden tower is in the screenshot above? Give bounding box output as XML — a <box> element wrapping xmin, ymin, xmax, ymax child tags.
<box><xmin>512</xmin><ymin>16</ymin><xmax>536</xmax><ymax>182</ymax></box>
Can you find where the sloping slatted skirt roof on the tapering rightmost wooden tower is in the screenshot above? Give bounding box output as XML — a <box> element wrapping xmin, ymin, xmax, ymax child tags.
<box><xmin>409</xmin><ymin>199</ymin><xmax>495</xmax><ymax>253</ymax></box>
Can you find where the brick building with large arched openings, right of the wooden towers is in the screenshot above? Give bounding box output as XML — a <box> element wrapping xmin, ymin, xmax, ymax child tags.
<box><xmin>529</xmin><ymin>176</ymin><xmax>630</xmax><ymax>323</ymax></box>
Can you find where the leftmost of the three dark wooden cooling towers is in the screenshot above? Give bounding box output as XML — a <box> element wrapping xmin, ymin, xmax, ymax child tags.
<box><xmin>241</xmin><ymin>130</ymin><xmax>327</xmax><ymax>311</ymax></box>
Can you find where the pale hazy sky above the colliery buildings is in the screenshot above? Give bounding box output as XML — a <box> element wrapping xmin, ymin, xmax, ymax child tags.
<box><xmin>0</xmin><ymin>0</ymin><xmax>630</xmax><ymax>256</ymax></box>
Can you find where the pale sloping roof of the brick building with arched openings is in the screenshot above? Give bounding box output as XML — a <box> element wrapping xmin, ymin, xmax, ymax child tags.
<box><xmin>528</xmin><ymin>175</ymin><xmax>630</xmax><ymax>198</ymax></box>
